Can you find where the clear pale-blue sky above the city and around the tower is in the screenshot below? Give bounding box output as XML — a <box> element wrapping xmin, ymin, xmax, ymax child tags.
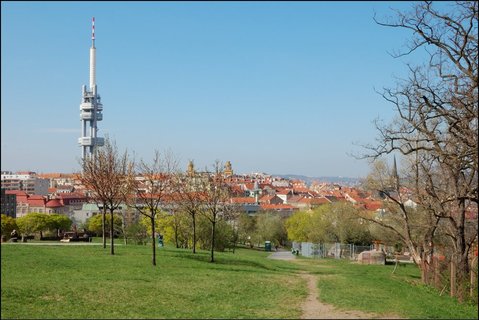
<box><xmin>1</xmin><ymin>1</ymin><xmax>442</xmax><ymax>177</ymax></box>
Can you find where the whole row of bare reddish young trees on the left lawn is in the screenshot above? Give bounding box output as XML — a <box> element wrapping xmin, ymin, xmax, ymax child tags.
<box><xmin>80</xmin><ymin>144</ymin><xmax>248</xmax><ymax>265</ymax></box>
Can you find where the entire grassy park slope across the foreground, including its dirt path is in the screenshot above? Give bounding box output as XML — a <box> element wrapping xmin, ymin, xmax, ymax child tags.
<box><xmin>1</xmin><ymin>241</ymin><xmax>478</xmax><ymax>319</ymax></box>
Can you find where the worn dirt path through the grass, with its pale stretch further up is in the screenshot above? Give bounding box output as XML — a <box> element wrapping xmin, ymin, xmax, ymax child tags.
<box><xmin>268</xmin><ymin>251</ymin><xmax>400</xmax><ymax>319</ymax></box>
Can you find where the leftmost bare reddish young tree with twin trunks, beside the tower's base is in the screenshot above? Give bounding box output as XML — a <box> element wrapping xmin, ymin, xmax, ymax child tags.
<box><xmin>80</xmin><ymin>139</ymin><xmax>133</xmax><ymax>255</ymax></box>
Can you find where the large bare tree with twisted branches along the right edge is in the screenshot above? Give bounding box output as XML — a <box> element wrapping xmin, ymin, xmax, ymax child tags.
<box><xmin>367</xmin><ymin>1</ymin><xmax>479</xmax><ymax>298</ymax></box>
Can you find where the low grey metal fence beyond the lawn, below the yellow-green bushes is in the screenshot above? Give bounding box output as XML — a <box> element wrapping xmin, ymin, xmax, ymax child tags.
<box><xmin>292</xmin><ymin>242</ymin><xmax>374</xmax><ymax>260</ymax></box>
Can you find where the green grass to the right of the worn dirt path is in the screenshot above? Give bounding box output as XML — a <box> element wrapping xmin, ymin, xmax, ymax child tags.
<box><xmin>298</xmin><ymin>258</ymin><xmax>478</xmax><ymax>319</ymax></box>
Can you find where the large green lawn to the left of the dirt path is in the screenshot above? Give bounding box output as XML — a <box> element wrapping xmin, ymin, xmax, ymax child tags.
<box><xmin>1</xmin><ymin>244</ymin><xmax>307</xmax><ymax>319</ymax></box>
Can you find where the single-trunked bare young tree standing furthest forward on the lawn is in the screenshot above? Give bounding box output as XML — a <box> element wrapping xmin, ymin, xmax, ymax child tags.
<box><xmin>131</xmin><ymin>150</ymin><xmax>177</xmax><ymax>266</ymax></box>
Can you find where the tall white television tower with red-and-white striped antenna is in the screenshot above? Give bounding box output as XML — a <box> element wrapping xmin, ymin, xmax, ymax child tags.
<box><xmin>78</xmin><ymin>17</ymin><xmax>105</xmax><ymax>160</ymax></box>
